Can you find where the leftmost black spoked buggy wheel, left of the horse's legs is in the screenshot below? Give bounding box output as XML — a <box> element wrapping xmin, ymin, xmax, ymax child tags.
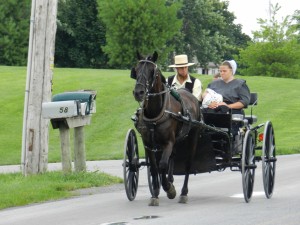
<box><xmin>123</xmin><ymin>129</ymin><xmax>139</xmax><ymax>201</ymax></box>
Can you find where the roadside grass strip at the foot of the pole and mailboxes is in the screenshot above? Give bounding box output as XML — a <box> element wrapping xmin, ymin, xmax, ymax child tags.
<box><xmin>0</xmin><ymin>171</ymin><xmax>122</xmax><ymax>210</ymax></box>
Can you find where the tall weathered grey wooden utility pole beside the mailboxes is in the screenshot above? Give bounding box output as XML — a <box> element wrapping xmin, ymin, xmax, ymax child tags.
<box><xmin>21</xmin><ymin>0</ymin><xmax>58</xmax><ymax>176</ymax></box>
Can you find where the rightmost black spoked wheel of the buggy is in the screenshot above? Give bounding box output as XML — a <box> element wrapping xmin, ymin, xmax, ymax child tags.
<box><xmin>262</xmin><ymin>121</ymin><xmax>276</xmax><ymax>198</ymax></box>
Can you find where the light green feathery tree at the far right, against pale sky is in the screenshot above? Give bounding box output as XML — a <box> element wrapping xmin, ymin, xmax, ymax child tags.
<box><xmin>238</xmin><ymin>4</ymin><xmax>300</xmax><ymax>78</ymax></box>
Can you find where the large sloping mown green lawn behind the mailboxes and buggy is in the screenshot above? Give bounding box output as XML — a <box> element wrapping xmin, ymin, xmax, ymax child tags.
<box><xmin>0</xmin><ymin>66</ymin><xmax>300</xmax><ymax>165</ymax></box>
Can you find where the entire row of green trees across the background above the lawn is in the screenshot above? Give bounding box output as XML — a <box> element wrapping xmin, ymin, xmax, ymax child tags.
<box><xmin>0</xmin><ymin>0</ymin><xmax>300</xmax><ymax>79</ymax></box>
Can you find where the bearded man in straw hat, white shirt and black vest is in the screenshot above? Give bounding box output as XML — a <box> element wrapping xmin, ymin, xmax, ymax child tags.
<box><xmin>167</xmin><ymin>55</ymin><xmax>202</xmax><ymax>101</ymax></box>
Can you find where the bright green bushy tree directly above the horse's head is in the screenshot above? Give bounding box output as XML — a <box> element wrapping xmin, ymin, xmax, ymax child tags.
<box><xmin>100</xmin><ymin>0</ymin><xmax>181</xmax><ymax>68</ymax></box>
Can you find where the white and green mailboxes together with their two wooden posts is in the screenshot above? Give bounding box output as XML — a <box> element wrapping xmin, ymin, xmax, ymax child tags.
<box><xmin>42</xmin><ymin>90</ymin><xmax>96</xmax><ymax>173</ymax></box>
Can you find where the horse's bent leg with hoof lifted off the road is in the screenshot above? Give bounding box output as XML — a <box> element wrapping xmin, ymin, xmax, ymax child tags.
<box><xmin>159</xmin><ymin>142</ymin><xmax>176</xmax><ymax>199</ymax></box>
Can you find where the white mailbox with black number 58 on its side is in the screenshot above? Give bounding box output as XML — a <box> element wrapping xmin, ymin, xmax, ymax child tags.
<box><xmin>42</xmin><ymin>100</ymin><xmax>81</xmax><ymax>119</ymax></box>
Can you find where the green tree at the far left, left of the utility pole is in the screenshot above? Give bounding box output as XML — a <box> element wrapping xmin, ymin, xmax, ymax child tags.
<box><xmin>0</xmin><ymin>0</ymin><xmax>31</xmax><ymax>66</ymax></box>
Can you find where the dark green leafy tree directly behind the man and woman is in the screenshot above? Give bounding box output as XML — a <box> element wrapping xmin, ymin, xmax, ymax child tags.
<box><xmin>171</xmin><ymin>0</ymin><xmax>250</xmax><ymax>70</ymax></box>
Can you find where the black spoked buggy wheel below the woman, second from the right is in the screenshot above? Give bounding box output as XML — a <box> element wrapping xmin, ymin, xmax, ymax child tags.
<box><xmin>242</xmin><ymin>130</ymin><xmax>256</xmax><ymax>202</ymax></box>
